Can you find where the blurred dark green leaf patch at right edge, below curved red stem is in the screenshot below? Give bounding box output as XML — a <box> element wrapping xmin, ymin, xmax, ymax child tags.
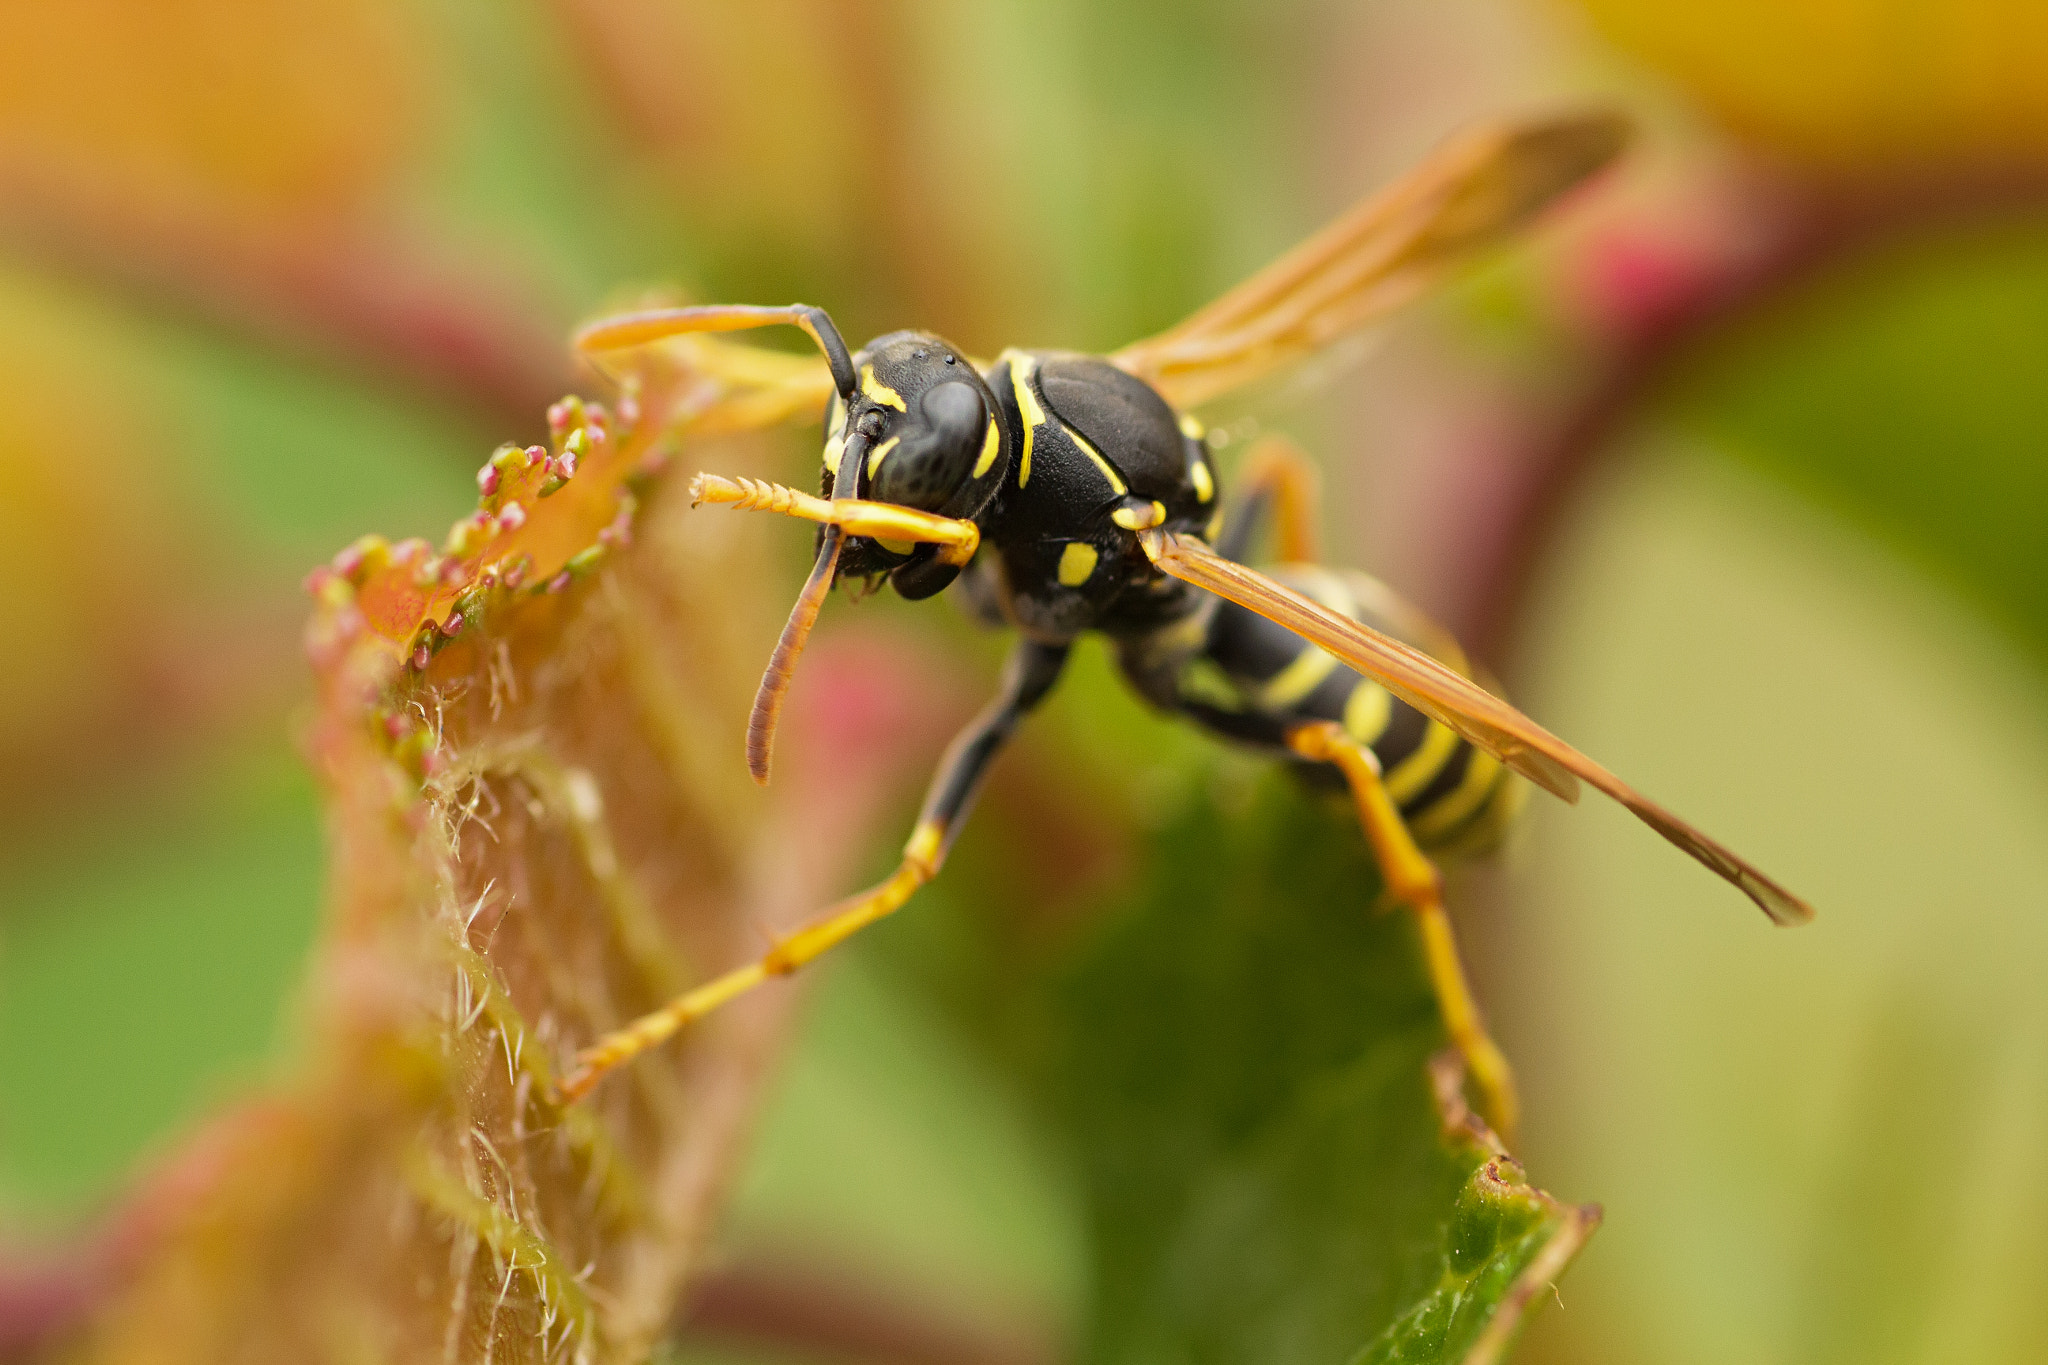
<box><xmin>1669</xmin><ymin>219</ymin><xmax>2048</xmax><ymax>659</ymax></box>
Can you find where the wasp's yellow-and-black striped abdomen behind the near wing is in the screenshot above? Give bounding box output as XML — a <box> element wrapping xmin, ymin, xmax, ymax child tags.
<box><xmin>1176</xmin><ymin>565</ymin><xmax>1524</xmax><ymax>853</ymax></box>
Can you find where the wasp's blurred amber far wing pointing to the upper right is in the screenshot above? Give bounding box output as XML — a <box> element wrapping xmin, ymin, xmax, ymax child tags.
<box><xmin>1110</xmin><ymin>113</ymin><xmax>1628</xmax><ymax>407</ymax></box>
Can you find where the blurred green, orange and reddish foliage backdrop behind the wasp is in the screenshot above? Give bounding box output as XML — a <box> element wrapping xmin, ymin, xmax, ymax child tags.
<box><xmin>0</xmin><ymin>0</ymin><xmax>2048</xmax><ymax>1363</ymax></box>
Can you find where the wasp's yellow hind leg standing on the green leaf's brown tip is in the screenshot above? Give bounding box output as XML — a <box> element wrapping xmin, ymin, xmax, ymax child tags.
<box><xmin>1288</xmin><ymin>720</ymin><xmax>1522</xmax><ymax>1146</ymax></box>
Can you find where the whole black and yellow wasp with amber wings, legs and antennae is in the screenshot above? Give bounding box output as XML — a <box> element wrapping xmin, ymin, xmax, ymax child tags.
<box><xmin>561</xmin><ymin>113</ymin><xmax>1812</xmax><ymax>1134</ymax></box>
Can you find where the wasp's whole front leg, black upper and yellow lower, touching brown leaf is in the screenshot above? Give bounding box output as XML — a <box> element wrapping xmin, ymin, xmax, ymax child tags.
<box><xmin>559</xmin><ymin>641</ymin><xmax>1067</xmax><ymax>1103</ymax></box>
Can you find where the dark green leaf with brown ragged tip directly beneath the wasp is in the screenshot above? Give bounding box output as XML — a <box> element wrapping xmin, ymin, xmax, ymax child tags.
<box><xmin>913</xmin><ymin>772</ymin><xmax>1597</xmax><ymax>1365</ymax></box>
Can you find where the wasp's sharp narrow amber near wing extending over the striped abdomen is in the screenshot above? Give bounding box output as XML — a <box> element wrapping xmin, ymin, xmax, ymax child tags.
<box><xmin>1139</xmin><ymin>530</ymin><xmax>1812</xmax><ymax>925</ymax></box>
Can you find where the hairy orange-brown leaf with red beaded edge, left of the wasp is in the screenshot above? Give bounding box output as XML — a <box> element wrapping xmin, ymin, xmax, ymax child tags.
<box><xmin>49</xmin><ymin>349</ymin><xmax>905</xmax><ymax>1365</ymax></box>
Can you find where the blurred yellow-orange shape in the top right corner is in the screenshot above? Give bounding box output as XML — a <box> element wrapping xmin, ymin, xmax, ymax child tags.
<box><xmin>1579</xmin><ymin>0</ymin><xmax>2048</xmax><ymax>174</ymax></box>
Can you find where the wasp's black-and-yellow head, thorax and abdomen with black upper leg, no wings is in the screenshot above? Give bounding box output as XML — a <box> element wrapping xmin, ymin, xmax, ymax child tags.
<box><xmin>825</xmin><ymin>332</ymin><xmax>1520</xmax><ymax>849</ymax></box>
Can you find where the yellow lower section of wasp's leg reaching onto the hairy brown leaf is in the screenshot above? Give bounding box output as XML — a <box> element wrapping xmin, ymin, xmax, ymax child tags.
<box><xmin>559</xmin><ymin>821</ymin><xmax>946</xmax><ymax>1103</ymax></box>
